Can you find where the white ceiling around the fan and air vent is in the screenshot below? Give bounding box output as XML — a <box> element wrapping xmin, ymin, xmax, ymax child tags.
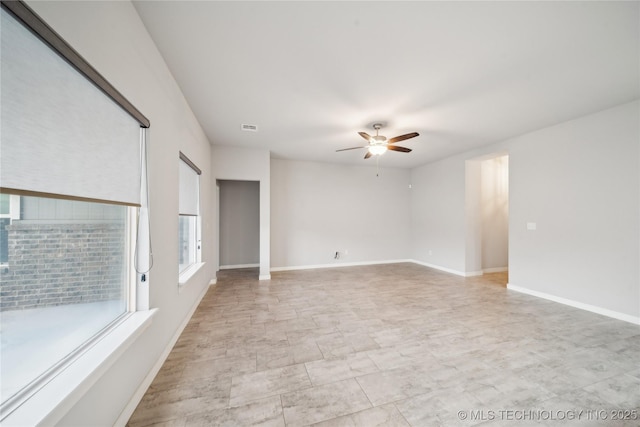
<box><xmin>134</xmin><ymin>1</ymin><xmax>640</xmax><ymax>167</ymax></box>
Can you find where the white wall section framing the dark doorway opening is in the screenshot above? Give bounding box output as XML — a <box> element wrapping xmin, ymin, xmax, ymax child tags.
<box><xmin>211</xmin><ymin>145</ymin><xmax>271</xmax><ymax>279</ymax></box>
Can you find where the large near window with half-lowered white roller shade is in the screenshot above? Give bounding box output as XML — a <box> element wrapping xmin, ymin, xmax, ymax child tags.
<box><xmin>0</xmin><ymin>2</ymin><xmax>149</xmax><ymax>424</ymax></box>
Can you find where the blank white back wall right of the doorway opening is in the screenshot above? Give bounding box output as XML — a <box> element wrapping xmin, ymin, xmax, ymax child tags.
<box><xmin>271</xmin><ymin>159</ymin><xmax>410</xmax><ymax>268</ymax></box>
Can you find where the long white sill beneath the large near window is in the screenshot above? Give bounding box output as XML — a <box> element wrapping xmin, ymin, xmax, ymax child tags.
<box><xmin>2</xmin><ymin>309</ymin><xmax>157</xmax><ymax>425</ymax></box>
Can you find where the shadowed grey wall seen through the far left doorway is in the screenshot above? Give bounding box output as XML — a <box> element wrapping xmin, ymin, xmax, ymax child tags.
<box><xmin>218</xmin><ymin>181</ymin><xmax>260</xmax><ymax>267</ymax></box>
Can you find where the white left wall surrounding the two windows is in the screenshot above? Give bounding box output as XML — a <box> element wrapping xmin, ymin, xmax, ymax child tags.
<box><xmin>28</xmin><ymin>1</ymin><xmax>214</xmax><ymax>426</ymax></box>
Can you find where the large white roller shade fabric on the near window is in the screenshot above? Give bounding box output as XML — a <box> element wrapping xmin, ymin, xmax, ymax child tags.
<box><xmin>0</xmin><ymin>10</ymin><xmax>140</xmax><ymax>205</ymax></box>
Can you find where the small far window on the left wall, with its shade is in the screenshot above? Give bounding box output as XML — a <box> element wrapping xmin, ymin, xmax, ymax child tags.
<box><xmin>178</xmin><ymin>153</ymin><xmax>201</xmax><ymax>284</ymax></box>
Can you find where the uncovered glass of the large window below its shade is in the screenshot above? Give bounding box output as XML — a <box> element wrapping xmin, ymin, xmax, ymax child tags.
<box><xmin>0</xmin><ymin>194</ymin><xmax>133</xmax><ymax>399</ymax></box>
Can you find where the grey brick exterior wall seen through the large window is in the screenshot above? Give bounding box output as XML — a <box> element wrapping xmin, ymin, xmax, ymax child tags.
<box><xmin>0</xmin><ymin>221</ymin><xmax>125</xmax><ymax>311</ymax></box>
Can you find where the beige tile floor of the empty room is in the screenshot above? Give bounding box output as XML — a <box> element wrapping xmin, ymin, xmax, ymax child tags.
<box><xmin>128</xmin><ymin>264</ymin><xmax>640</xmax><ymax>427</ymax></box>
